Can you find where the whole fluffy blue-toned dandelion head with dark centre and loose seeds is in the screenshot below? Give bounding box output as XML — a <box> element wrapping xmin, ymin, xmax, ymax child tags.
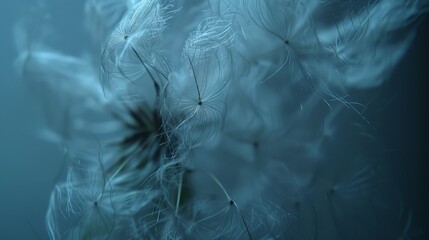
<box><xmin>16</xmin><ymin>0</ymin><xmax>429</xmax><ymax>240</ymax></box>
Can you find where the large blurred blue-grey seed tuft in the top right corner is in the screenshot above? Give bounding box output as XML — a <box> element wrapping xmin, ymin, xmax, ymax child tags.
<box><xmin>318</xmin><ymin>1</ymin><xmax>427</xmax><ymax>88</ymax></box>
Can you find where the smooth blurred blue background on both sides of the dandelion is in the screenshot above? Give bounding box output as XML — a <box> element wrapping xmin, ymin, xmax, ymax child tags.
<box><xmin>0</xmin><ymin>0</ymin><xmax>429</xmax><ymax>240</ymax></box>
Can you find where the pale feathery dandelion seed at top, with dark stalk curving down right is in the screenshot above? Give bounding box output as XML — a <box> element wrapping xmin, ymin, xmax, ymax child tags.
<box><xmin>100</xmin><ymin>0</ymin><xmax>172</xmax><ymax>97</ymax></box>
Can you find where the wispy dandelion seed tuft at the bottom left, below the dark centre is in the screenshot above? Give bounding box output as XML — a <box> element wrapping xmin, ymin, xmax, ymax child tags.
<box><xmin>47</xmin><ymin>150</ymin><xmax>116</xmax><ymax>239</ymax></box>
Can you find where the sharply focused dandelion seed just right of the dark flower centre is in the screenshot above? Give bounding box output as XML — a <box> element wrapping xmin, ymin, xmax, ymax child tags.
<box><xmin>161</xmin><ymin>18</ymin><xmax>232</xmax><ymax>146</ymax></box>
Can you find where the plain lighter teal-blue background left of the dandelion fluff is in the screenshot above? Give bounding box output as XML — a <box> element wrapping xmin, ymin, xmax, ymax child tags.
<box><xmin>0</xmin><ymin>0</ymin><xmax>85</xmax><ymax>240</ymax></box>
